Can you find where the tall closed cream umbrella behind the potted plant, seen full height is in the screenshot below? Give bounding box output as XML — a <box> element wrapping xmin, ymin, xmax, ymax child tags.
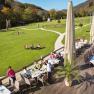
<box><xmin>65</xmin><ymin>0</ymin><xmax>75</xmax><ymax>64</ymax></box>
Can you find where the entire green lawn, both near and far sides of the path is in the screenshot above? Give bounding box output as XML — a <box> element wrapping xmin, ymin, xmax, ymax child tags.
<box><xmin>0</xmin><ymin>17</ymin><xmax>90</xmax><ymax>76</ymax></box>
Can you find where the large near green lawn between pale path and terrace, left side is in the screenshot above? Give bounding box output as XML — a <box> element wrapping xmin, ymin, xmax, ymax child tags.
<box><xmin>0</xmin><ymin>29</ymin><xmax>57</xmax><ymax>76</ymax></box>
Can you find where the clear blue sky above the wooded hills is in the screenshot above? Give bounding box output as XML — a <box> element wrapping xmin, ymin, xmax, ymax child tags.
<box><xmin>18</xmin><ymin>0</ymin><xmax>86</xmax><ymax>10</ymax></box>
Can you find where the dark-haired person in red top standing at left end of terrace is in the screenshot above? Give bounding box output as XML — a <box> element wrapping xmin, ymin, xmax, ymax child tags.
<box><xmin>7</xmin><ymin>66</ymin><xmax>16</xmax><ymax>85</ymax></box>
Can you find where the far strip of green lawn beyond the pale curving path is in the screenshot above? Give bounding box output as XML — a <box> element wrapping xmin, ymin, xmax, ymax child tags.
<box><xmin>23</xmin><ymin>17</ymin><xmax>90</xmax><ymax>34</ymax></box>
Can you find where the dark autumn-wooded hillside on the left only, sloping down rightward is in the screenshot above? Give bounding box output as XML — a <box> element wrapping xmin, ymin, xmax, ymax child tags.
<box><xmin>0</xmin><ymin>0</ymin><xmax>48</xmax><ymax>28</ymax></box>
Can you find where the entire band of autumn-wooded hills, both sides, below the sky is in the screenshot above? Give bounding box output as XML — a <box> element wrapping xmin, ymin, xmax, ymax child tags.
<box><xmin>0</xmin><ymin>0</ymin><xmax>94</xmax><ymax>28</ymax></box>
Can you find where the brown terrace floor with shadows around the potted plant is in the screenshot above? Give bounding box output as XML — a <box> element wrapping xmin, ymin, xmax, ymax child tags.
<box><xmin>29</xmin><ymin>54</ymin><xmax>94</xmax><ymax>94</ymax></box>
